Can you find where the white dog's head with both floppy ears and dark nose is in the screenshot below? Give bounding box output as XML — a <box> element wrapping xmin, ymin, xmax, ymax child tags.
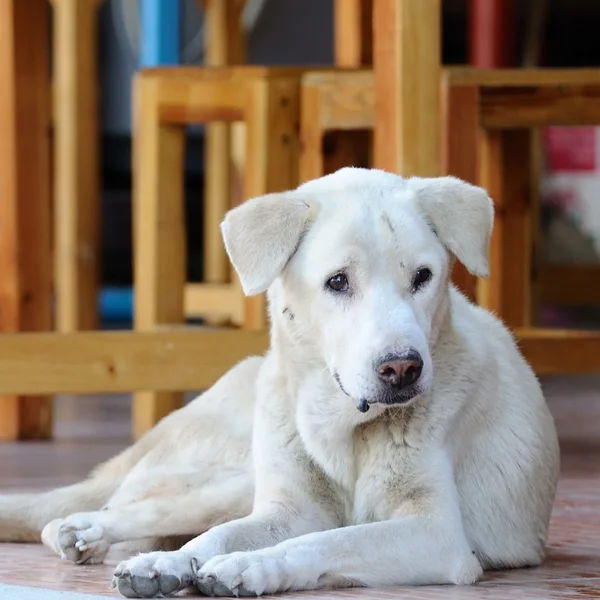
<box><xmin>222</xmin><ymin>168</ymin><xmax>493</xmax><ymax>410</ymax></box>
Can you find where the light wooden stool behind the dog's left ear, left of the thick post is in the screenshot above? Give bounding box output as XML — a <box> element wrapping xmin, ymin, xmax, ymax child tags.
<box><xmin>133</xmin><ymin>67</ymin><xmax>303</xmax><ymax>436</ymax></box>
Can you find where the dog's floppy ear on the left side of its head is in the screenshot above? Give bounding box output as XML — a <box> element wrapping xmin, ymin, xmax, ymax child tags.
<box><xmin>221</xmin><ymin>192</ymin><xmax>311</xmax><ymax>296</ymax></box>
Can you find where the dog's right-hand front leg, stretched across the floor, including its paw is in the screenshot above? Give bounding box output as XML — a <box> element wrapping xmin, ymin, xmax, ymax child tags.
<box><xmin>196</xmin><ymin>479</ymin><xmax>482</xmax><ymax>595</ymax></box>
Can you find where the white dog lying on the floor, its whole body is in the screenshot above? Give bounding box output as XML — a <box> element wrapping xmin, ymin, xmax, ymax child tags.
<box><xmin>0</xmin><ymin>169</ymin><xmax>559</xmax><ymax>597</ymax></box>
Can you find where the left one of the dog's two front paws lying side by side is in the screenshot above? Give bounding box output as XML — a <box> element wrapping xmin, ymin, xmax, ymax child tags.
<box><xmin>112</xmin><ymin>551</ymin><xmax>194</xmax><ymax>598</ymax></box>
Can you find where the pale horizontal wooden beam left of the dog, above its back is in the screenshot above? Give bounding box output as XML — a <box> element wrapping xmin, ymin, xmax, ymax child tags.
<box><xmin>0</xmin><ymin>330</ymin><xmax>269</xmax><ymax>396</ymax></box>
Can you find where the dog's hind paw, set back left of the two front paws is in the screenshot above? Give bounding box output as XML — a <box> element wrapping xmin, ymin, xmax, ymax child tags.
<box><xmin>42</xmin><ymin>513</ymin><xmax>110</xmax><ymax>565</ymax></box>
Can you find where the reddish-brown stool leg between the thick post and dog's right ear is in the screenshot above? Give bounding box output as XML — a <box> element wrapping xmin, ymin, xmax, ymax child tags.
<box><xmin>442</xmin><ymin>81</ymin><xmax>479</xmax><ymax>302</ymax></box>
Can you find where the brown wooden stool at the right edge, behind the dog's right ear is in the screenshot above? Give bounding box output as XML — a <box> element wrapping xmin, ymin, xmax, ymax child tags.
<box><xmin>442</xmin><ymin>69</ymin><xmax>600</xmax><ymax>328</ymax></box>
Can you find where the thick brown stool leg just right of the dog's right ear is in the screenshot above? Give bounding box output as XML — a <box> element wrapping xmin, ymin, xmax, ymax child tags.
<box><xmin>477</xmin><ymin>130</ymin><xmax>533</xmax><ymax>327</ymax></box>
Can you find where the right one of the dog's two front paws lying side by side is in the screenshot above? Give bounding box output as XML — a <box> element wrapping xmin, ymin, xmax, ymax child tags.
<box><xmin>196</xmin><ymin>549</ymin><xmax>313</xmax><ymax>596</ymax></box>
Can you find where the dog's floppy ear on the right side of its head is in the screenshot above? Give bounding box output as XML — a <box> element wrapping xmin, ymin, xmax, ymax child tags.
<box><xmin>408</xmin><ymin>177</ymin><xmax>494</xmax><ymax>277</ymax></box>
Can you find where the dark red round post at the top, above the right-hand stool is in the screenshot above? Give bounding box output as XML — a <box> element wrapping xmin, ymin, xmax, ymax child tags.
<box><xmin>469</xmin><ymin>0</ymin><xmax>514</xmax><ymax>69</ymax></box>
